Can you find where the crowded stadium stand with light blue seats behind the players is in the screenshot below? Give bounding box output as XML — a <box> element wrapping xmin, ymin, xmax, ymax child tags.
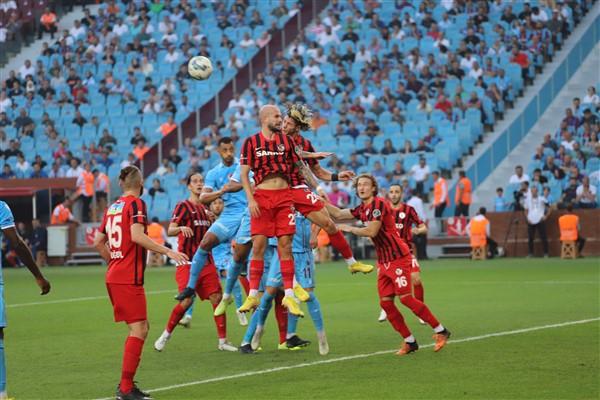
<box><xmin>0</xmin><ymin>0</ymin><xmax>593</xmax><ymax>219</ymax></box>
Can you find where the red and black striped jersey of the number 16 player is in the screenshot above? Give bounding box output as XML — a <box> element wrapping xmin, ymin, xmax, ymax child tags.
<box><xmin>351</xmin><ymin>196</ymin><xmax>410</xmax><ymax>263</ymax></box>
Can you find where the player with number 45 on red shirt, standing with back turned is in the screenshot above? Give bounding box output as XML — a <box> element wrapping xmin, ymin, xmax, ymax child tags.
<box><xmin>94</xmin><ymin>166</ymin><xmax>188</xmax><ymax>400</ymax></box>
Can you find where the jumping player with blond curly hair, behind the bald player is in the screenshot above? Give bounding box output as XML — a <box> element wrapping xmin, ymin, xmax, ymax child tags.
<box><xmin>283</xmin><ymin>104</ymin><xmax>374</xmax><ymax>273</ymax></box>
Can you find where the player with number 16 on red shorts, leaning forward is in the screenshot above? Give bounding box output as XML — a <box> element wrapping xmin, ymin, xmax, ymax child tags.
<box><xmin>327</xmin><ymin>175</ymin><xmax>450</xmax><ymax>355</ymax></box>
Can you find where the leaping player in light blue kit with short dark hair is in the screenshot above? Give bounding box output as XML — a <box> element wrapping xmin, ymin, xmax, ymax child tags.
<box><xmin>176</xmin><ymin>137</ymin><xmax>251</xmax><ymax>301</ymax></box>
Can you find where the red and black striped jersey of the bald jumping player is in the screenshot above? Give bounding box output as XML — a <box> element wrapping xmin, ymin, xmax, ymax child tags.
<box><xmin>240</xmin><ymin>132</ymin><xmax>300</xmax><ymax>185</ymax></box>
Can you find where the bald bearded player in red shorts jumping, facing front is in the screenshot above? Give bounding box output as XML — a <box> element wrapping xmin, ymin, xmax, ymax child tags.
<box><xmin>239</xmin><ymin>105</ymin><xmax>304</xmax><ymax>316</ymax></box>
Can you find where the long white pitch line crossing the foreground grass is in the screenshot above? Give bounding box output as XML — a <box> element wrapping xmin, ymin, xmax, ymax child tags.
<box><xmin>96</xmin><ymin>317</ymin><xmax>600</xmax><ymax>400</ymax></box>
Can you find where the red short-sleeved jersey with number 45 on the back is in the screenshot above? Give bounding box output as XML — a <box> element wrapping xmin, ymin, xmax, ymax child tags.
<box><xmin>100</xmin><ymin>196</ymin><xmax>148</xmax><ymax>286</ymax></box>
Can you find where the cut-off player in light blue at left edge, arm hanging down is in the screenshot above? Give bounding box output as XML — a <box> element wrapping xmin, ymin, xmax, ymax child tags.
<box><xmin>0</xmin><ymin>200</ymin><xmax>50</xmax><ymax>400</ymax></box>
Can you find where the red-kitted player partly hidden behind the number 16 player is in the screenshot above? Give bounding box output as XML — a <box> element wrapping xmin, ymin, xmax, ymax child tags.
<box><xmin>379</xmin><ymin>184</ymin><xmax>427</xmax><ymax>325</ymax></box>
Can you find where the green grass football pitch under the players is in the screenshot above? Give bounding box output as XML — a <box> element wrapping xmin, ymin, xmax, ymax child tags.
<box><xmin>4</xmin><ymin>258</ymin><xmax>600</xmax><ymax>400</ymax></box>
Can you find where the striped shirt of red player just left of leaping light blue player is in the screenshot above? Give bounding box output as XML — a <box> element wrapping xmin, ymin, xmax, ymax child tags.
<box><xmin>171</xmin><ymin>200</ymin><xmax>213</xmax><ymax>263</ymax></box>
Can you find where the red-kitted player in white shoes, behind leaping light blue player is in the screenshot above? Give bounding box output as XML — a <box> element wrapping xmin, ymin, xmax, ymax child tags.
<box><xmin>154</xmin><ymin>173</ymin><xmax>237</xmax><ymax>351</ymax></box>
